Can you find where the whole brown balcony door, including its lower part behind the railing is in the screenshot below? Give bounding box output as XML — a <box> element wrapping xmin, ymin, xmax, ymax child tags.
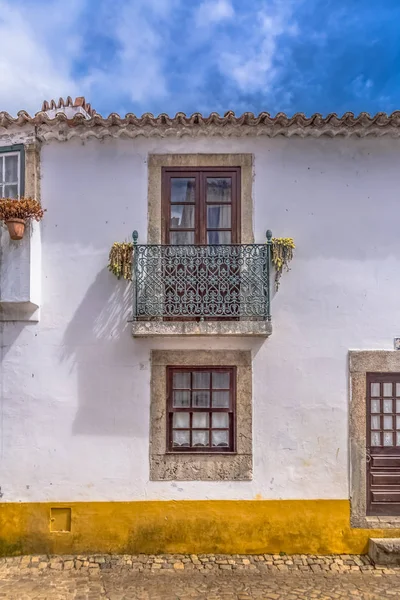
<box><xmin>162</xmin><ymin>167</ymin><xmax>240</xmax><ymax>319</ymax></box>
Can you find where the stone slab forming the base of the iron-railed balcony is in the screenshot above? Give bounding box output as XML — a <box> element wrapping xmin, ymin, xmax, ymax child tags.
<box><xmin>132</xmin><ymin>321</ymin><xmax>272</xmax><ymax>338</ymax></box>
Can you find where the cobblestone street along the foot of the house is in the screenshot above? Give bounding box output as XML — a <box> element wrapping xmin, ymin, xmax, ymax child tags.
<box><xmin>0</xmin><ymin>555</ymin><xmax>400</xmax><ymax>600</ymax></box>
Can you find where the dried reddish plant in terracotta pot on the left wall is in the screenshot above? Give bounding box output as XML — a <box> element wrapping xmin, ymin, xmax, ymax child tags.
<box><xmin>0</xmin><ymin>198</ymin><xmax>45</xmax><ymax>240</ymax></box>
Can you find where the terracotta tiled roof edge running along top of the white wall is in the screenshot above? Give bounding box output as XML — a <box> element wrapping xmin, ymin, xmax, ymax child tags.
<box><xmin>0</xmin><ymin>102</ymin><xmax>400</xmax><ymax>140</ymax></box>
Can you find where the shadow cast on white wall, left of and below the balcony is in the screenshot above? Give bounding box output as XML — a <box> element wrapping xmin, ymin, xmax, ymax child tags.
<box><xmin>61</xmin><ymin>269</ymin><xmax>148</xmax><ymax>437</ymax></box>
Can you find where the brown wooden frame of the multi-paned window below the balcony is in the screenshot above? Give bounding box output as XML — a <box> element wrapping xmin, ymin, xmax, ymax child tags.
<box><xmin>166</xmin><ymin>366</ymin><xmax>237</xmax><ymax>454</ymax></box>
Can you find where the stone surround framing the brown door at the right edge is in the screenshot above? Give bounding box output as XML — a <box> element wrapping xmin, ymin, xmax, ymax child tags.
<box><xmin>349</xmin><ymin>350</ymin><xmax>400</xmax><ymax>529</ymax></box>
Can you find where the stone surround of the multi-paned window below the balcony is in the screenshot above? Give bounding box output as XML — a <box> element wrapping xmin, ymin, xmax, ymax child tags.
<box><xmin>150</xmin><ymin>350</ymin><xmax>253</xmax><ymax>481</ymax></box>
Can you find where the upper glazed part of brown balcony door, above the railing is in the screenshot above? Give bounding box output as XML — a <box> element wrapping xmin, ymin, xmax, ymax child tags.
<box><xmin>162</xmin><ymin>167</ymin><xmax>240</xmax><ymax>245</ymax></box>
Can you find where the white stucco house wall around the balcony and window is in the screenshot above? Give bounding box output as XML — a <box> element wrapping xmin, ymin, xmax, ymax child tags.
<box><xmin>0</xmin><ymin>138</ymin><xmax>400</xmax><ymax>502</ymax></box>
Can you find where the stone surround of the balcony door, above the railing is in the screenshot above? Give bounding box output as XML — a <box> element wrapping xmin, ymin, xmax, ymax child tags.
<box><xmin>147</xmin><ymin>154</ymin><xmax>254</xmax><ymax>244</ymax></box>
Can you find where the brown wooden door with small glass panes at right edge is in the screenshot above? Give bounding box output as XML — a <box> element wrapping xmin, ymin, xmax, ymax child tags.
<box><xmin>366</xmin><ymin>373</ymin><xmax>400</xmax><ymax>516</ymax></box>
